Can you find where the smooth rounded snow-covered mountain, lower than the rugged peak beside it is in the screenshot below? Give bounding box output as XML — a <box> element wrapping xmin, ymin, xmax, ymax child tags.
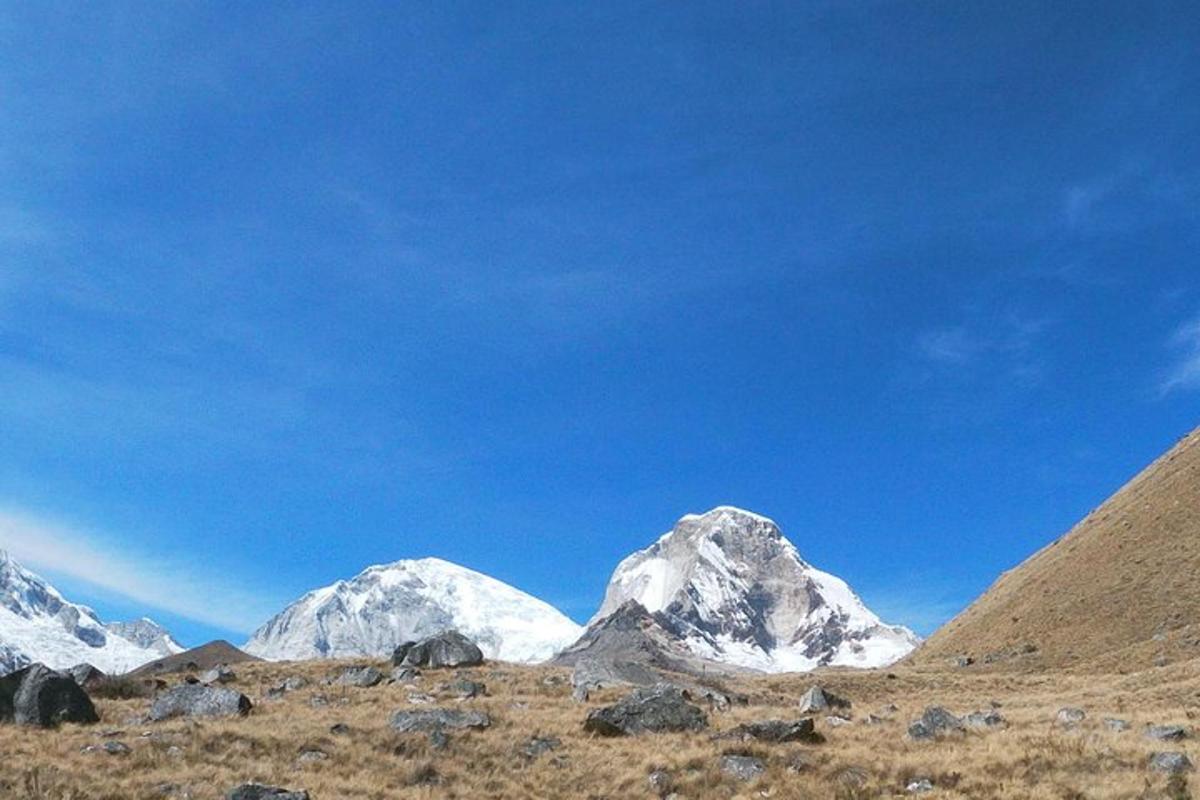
<box><xmin>242</xmin><ymin>558</ymin><xmax>582</xmax><ymax>662</ymax></box>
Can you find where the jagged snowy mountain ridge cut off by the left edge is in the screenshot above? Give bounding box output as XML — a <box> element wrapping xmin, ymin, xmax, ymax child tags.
<box><xmin>0</xmin><ymin>551</ymin><xmax>179</xmax><ymax>674</ymax></box>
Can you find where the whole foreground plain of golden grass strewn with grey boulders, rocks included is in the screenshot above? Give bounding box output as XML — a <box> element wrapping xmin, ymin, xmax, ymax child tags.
<box><xmin>0</xmin><ymin>640</ymin><xmax>1200</xmax><ymax>800</ymax></box>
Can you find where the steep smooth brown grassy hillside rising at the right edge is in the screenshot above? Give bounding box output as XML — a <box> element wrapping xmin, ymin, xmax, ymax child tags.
<box><xmin>910</xmin><ymin>429</ymin><xmax>1200</xmax><ymax>672</ymax></box>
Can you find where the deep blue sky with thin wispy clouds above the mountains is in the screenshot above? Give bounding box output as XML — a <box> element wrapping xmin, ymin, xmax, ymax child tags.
<box><xmin>0</xmin><ymin>0</ymin><xmax>1200</xmax><ymax>644</ymax></box>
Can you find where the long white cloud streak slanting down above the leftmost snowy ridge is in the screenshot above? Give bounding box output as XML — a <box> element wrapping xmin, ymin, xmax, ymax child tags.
<box><xmin>0</xmin><ymin>506</ymin><xmax>278</xmax><ymax>632</ymax></box>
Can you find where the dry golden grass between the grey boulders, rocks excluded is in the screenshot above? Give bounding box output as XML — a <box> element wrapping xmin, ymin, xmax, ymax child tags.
<box><xmin>0</xmin><ymin>662</ymin><xmax>1200</xmax><ymax>800</ymax></box>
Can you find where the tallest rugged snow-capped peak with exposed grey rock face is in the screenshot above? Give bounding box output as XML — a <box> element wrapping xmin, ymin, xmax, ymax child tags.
<box><xmin>593</xmin><ymin>506</ymin><xmax>919</xmax><ymax>672</ymax></box>
